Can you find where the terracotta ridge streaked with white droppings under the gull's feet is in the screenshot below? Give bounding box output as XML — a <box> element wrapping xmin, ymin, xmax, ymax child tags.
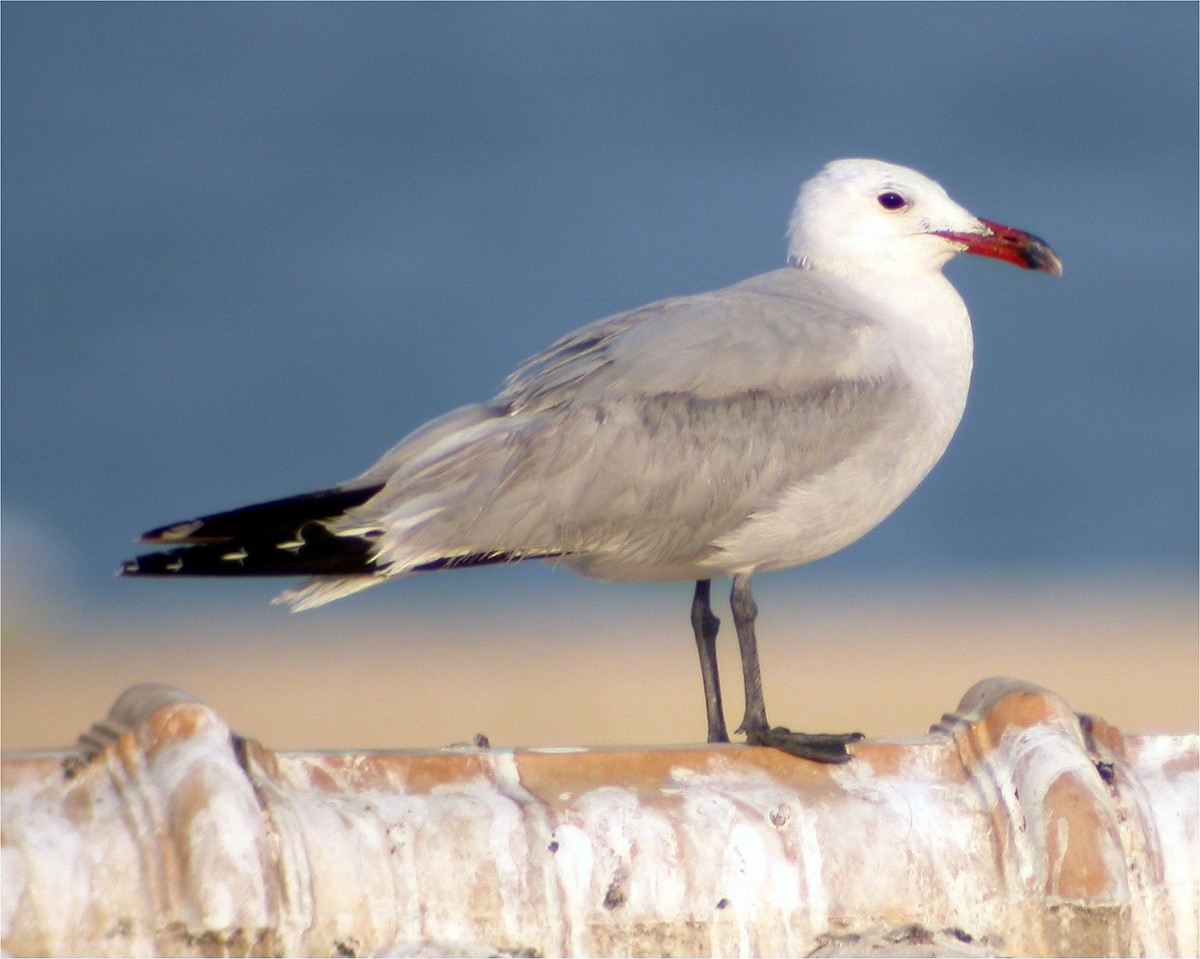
<box><xmin>2</xmin><ymin>679</ymin><xmax>1200</xmax><ymax>955</ymax></box>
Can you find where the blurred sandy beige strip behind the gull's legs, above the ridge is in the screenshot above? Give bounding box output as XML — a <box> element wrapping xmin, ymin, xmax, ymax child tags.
<box><xmin>2</xmin><ymin>582</ymin><xmax>1200</xmax><ymax>750</ymax></box>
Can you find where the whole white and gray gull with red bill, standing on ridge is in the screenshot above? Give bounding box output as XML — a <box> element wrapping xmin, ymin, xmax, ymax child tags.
<box><xmin>122</xmin><ymin>160</ymin><xmax>1062</xmax><ymax>762</ymax></box>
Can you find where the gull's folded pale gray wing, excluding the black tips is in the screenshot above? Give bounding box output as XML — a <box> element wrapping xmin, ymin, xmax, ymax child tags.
<box><xmin>283</xmin><ymin>270</ymin><xmax>906</xmax><ymax>604</ymax></box>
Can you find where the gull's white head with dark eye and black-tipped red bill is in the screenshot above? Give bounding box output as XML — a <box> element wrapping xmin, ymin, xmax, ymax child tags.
<box><xmin>787</xmin><ymin>160</ymin><xmax>1062</xmax><ymax>276</ymax></box>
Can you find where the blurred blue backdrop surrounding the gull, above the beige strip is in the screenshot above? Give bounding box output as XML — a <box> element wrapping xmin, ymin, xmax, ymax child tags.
<box><xmin>0</xmin><ymin>4</ymin><xmax>1198</xmax><ymax>628</ymax></box>
